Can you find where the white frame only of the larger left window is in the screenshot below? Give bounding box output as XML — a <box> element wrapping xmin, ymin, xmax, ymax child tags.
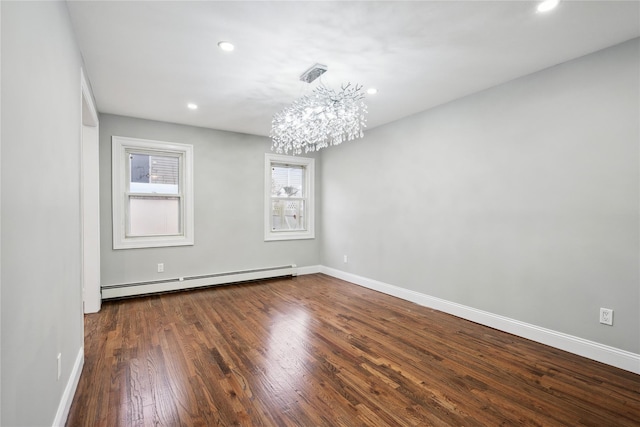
<box><xmin>111</xmin><ymin>135</ymin><xmax>194</xmax><ymax>249</ymax></box>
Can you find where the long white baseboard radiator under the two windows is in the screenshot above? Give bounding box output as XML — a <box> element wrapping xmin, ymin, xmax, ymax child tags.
<box><xmin>101</xmin><ymin>264</ymin><xmax>296</xmax><ymax>300</ymax></box>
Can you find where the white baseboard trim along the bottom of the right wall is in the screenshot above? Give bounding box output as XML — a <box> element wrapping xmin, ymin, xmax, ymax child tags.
<box><xmin>320</xmin><ymin>266</ymin><xmax>640</xmax><ymax>374</ymax></box>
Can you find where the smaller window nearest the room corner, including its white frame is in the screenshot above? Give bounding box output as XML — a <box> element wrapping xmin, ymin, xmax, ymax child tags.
<box><xmin>264</xmin><ymin>154</ymin><xmax>315</xmax><ymax>240</ymax></box>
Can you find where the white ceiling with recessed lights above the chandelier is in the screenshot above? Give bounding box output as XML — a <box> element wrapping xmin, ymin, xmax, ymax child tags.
<box><xmin>68</xmin><ymin>1</ymin><xmax>640</xmax><ymax>135</ymax></box>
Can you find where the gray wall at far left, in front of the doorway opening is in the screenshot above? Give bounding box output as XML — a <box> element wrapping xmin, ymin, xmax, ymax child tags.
<box><xmin>0</xmin><ymin>1</ymin><xmax>83</xmax><ymax>426</ymax></box>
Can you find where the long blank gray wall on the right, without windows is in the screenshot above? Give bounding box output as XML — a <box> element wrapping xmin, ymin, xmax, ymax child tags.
<box><xmin>321</xmin><ymin>39</ymin><xmax>640</xmax><ymax>353</ymax></box>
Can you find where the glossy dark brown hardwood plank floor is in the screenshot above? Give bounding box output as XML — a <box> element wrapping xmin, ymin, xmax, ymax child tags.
<box><xmin>67</xmin><ymin>275</ymin><xmax>640</xmax><ymax>426</ymax></box>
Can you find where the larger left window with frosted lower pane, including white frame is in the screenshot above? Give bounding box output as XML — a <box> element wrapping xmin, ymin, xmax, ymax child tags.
<box><xmin>112</xmin><ymin>136</ymin><xmax>193</xmax><ymax>249</ymax></box>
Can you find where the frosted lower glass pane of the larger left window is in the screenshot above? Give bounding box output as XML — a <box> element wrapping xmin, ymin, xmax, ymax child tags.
<box><xmin>129</xmin><ymin>196</ymin><xmax>181</xmax><ymax>236</ymax></box>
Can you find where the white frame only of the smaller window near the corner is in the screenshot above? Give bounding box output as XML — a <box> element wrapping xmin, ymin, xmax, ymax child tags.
<box><xmin>264</xmin><ymin>153</ymin><xmax>316</xmax><ymax>241</ymax></box>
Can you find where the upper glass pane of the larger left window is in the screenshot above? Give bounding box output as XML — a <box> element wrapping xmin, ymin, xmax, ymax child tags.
<box><xmin>129</xmin><ymin>153</ymin><xmax>180</xmax><ymax>194</ymax></box>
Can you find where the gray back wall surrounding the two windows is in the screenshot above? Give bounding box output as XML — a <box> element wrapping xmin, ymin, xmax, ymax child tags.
<box><xmin>100</xmin><ymin>114</ymin><xmax>321</xmax><ymax>285</ymax></box>
